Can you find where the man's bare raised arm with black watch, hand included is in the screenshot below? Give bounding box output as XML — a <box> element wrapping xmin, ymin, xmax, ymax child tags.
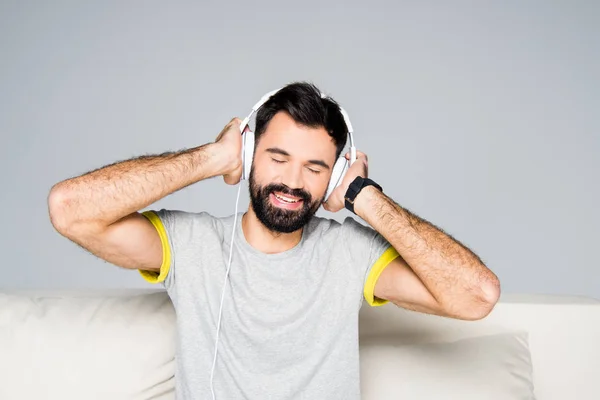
<box><xmin>325</xmin><ymin>152</ymin><xmax>500</xmax><ymax>320</ymax></box>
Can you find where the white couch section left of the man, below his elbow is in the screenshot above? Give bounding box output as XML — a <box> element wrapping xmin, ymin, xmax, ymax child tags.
<box><xmin>0</xmin><ymin>292</ymin><xmax>175</xmax><ymax>400</ymax></box>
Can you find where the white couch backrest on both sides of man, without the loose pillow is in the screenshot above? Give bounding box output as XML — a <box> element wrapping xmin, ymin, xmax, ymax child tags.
<box><xmin>0</xmin><ymin>289</ymin><xmax>600</xmax><ymax>400</ymax></box>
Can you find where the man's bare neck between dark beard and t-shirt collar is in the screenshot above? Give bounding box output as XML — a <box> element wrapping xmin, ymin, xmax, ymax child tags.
<box><xmin>242</xmin><ymin>207</ymin><xmax>302</xmax><ymax>254</ymax></box>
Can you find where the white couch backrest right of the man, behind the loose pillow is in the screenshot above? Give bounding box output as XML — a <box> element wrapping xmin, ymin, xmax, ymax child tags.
<box><xmin>360</xmin><ymin>295</ymin><xmax>600</xmax><ymax>400</ymax></box>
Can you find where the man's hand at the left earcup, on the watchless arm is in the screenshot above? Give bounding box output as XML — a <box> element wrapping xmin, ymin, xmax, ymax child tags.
<box><xmin>215</xmin><ymin>117</ymin><xmax>249</xmax><ymax>185</ymax></box>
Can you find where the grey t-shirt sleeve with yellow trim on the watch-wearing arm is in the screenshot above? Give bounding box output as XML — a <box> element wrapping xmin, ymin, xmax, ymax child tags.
<box><xmin>342</xmin><ymin>217</ymin><xmax>399</xmax><ymax>306</ymax></box>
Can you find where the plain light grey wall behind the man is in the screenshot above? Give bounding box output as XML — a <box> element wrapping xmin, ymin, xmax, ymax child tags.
<box><xmin>0</xmin><ymin>0</ymin><xmax>600</xmax><ymax>298</ymax></box>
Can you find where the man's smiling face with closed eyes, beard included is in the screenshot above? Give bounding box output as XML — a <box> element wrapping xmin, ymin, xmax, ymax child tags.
<box><xmin>249</xmin><ymin>112</ymin><xmax>336</xmax><ymax>233</ymax></box>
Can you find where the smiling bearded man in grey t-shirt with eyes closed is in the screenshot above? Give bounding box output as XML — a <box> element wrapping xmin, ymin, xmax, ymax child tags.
<box><xmin>48</xmin><ymin>83</ymin><xmax>500</xmax><ymax>399</ymax></box>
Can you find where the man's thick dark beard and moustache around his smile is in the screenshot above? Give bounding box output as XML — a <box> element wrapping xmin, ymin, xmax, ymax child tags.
<box><xmin>248</xmin><ymin>169</ymin><xmax>324</xmax><ymax>233</ymax></box>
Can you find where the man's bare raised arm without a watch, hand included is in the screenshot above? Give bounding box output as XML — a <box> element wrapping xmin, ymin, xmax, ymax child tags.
<box><xmin>48</xmin><ymin>118</ymin><xmax>241</xmax><ymax>271</ymax></box>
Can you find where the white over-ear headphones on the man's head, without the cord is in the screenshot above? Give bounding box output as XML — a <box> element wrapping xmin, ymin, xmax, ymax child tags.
<box><xmin>240</xmin><ymin>88</ymin><xmax>356</xmax><ymax>201</ymax></box>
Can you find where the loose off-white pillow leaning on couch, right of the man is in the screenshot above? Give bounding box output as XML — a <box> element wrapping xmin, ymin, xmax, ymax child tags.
<box><xmin>361</xmin><ymin>332</ymin><xmax>535</xmax><ymax>400</ymax></box>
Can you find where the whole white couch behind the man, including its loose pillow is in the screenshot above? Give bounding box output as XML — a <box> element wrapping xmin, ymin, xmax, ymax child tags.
<box><xmin>0</xmin><ymin>289</ymin><xmax>600</xmax><ymax>400</ymax></box>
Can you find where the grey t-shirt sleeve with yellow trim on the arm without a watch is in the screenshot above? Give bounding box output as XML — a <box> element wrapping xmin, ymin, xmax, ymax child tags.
<box><xmin>139</xmin><ymin>209</ymin><xmax>177</xmax><ymax>289</ymax></box>
